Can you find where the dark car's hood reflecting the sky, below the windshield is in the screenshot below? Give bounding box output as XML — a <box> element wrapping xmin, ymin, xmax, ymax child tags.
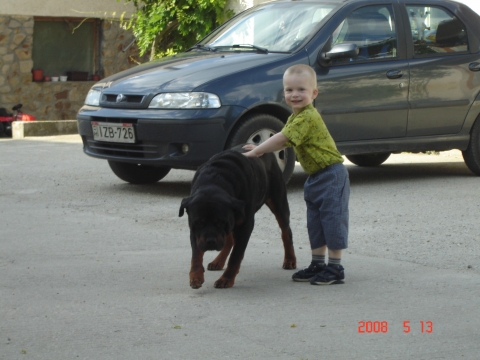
<box><xmin>95</xmin><ymin>51</ymin><xmax>289</xmax><ymax>95</ymax></box>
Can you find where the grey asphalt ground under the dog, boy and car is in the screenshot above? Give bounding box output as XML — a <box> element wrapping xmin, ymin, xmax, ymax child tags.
<box><xmin>0</xmin><ymin>136</ymin><xmax>480</xmax><ymax>360</ymax></box>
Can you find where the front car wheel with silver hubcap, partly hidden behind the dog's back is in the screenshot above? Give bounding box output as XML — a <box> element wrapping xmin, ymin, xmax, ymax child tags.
<box><xmin>227</xmin><ymin>114</ymin><xmax>295</xmax><ymax>183</ymax></box>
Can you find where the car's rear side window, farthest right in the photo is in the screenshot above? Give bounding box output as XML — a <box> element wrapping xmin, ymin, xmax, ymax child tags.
<box><xmin>407</xmin><ymin>5</ymin><xmax>468</xmax><ymax>55</ymax></box>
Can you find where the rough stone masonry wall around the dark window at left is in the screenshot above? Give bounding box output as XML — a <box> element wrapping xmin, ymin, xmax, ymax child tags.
<box><xmin>0</xmin><ymin>16</ymin><xmax>143</xmax><ymax>120</ymax></box>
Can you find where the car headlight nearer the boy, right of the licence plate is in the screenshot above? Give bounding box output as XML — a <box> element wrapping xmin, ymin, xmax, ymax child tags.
<box><xmin>148</xmin><ymin>92</ymin><xmax>222</xmax><ymax>109</ymax></box>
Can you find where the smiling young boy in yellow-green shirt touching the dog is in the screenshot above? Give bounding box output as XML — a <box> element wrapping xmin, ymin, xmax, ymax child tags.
<box><xmin>244</xmin><ymin>65</ymin><xmax>350</xmax><ymax>285</ymax></box>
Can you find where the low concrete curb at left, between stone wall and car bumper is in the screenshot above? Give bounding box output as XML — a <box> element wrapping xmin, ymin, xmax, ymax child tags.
<box><xmin>12</xmin><ymin>120</ymin><xmax>78</xmax><ymax>139</ymax></box>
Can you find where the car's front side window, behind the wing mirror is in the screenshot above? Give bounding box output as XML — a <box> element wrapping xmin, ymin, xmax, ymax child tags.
<box><xmin>332</xmin><ymin>5</ymin><xmax>397</xmax><ymax>65</ymax></box>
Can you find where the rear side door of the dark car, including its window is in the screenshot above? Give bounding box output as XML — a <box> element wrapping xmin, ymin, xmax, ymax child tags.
<box><xmin>405</xmin><ymin>3</ymin><xmax>480</xmax><ymax>136</ymax></box>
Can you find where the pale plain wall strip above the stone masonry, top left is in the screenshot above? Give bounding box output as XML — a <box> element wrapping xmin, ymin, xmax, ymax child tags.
<box><xmin>0</xmin><ymin>0</ymin><xmax>135</xmax><ymax>18</ymax></box>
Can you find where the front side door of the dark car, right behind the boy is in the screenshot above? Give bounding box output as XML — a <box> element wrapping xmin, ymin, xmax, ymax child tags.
<box><xmin>315</xmin><ymin>4</ymin><xmax>409</xmax><ymax>142</ymax></box>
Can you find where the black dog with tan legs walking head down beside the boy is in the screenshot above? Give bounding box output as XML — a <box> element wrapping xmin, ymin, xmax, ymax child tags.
<box><xmin>179</xmin><ymin>147</ymin><xmax>296</xmax><ymax>289</ymax></box>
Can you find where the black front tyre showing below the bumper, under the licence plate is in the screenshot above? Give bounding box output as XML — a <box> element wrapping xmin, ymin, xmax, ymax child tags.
<box><xmin>108</xmin><ymin>160</ymin><xmax>171</xmax><ymax>184</ymax></box>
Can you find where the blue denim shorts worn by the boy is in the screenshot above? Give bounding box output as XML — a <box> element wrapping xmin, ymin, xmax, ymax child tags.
<box><xmin>303</xmin><ymin>163</ymin><xmax>350</xmax><ymax>250</ymax></box>
